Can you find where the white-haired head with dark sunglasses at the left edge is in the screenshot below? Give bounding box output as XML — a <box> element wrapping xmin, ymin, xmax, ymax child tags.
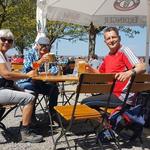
<box><xmin>0</xmin><ymin>29</ymin><xmax>14</xmax><ymax>53</ymax></box>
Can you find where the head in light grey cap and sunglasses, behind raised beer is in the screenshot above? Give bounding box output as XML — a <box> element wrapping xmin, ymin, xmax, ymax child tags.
<box><xmin>36</xmin><ymin>37</ymin><xmax>50</xmax><ymax>56</ymax></box>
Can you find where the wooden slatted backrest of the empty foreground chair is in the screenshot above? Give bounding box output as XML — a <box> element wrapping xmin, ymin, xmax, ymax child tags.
<box><xmin>76</xmin><ymin>73</ymin><xmax>116</xmax><ymax>106</ymax></box>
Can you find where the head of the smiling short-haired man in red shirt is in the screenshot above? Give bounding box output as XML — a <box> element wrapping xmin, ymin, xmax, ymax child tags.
<box><xmin>104</xmin><ymin>27</ymin><xmax>121</xmax><ymax>54</ymax></box>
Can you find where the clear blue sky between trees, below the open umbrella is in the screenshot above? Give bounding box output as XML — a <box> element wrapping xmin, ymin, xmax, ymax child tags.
<box><xmin>52</xmin><ymin>27</ymin><xmax>146</xmax><ymax>56</ymax></box>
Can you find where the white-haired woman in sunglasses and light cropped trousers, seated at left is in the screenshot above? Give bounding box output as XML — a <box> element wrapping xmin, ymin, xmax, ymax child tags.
<box><xmin>0</xmin><ymin>29</ymin><xmax>43</xmax><ymax>143</ymax></box>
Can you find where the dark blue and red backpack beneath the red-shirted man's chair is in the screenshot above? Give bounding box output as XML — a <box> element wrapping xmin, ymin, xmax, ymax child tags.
<box><xmin>109</xmin><ymin>105</ymin><xmax>145</xmax><ymax>140</ymax></box>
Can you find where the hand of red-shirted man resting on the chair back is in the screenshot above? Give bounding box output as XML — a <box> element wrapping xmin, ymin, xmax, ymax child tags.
<box><xmin>115</xmin><ymin>70</ymin><xmax>133</xmax><ymax>82</ymax></box>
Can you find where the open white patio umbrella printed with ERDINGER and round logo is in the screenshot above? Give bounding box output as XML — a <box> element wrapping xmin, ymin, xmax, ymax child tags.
<box><xmin>37</xmin><ymin>0</ymin><xmax>150</xmax><ymax>70</ymax></box>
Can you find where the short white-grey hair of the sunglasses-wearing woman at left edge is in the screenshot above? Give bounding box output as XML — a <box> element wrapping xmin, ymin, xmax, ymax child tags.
<box><xmin>0</xmin><ymin>29</ymin><xmax>14</xmax><ymax>40</ymax></box>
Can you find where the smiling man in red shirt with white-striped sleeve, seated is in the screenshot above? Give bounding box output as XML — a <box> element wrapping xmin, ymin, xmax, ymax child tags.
<box><xmin>82</xmin><ymin>27</ymin><xmax>145</xmax><ymax>108</ymax></box>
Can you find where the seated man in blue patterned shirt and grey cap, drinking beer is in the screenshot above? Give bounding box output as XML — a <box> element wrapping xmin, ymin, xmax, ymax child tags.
<box><xmin>17</xmin><ymin>37</ymin><xmax>59</xmax><ymax>120</ymax></box>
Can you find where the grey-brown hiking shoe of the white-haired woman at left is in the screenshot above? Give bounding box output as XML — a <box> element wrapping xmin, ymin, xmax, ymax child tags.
<box><xmin>20</xmin><ymin>129</ymin><xmax>43</xmax><ymax>143</ymax></box>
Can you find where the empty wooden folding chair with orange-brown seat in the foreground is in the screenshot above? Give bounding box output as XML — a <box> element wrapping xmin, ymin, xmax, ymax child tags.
<box><xmin>54</xmin><ymin>74</ymin><xmax>116</xmax><ymax>149</ymax></box>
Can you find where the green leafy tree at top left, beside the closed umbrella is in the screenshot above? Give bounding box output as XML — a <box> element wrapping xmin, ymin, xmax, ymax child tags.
<box><xmin>0</xmin><ymin>0</ymin><xmax>36</xmax><ymax>50</ymax></box>
